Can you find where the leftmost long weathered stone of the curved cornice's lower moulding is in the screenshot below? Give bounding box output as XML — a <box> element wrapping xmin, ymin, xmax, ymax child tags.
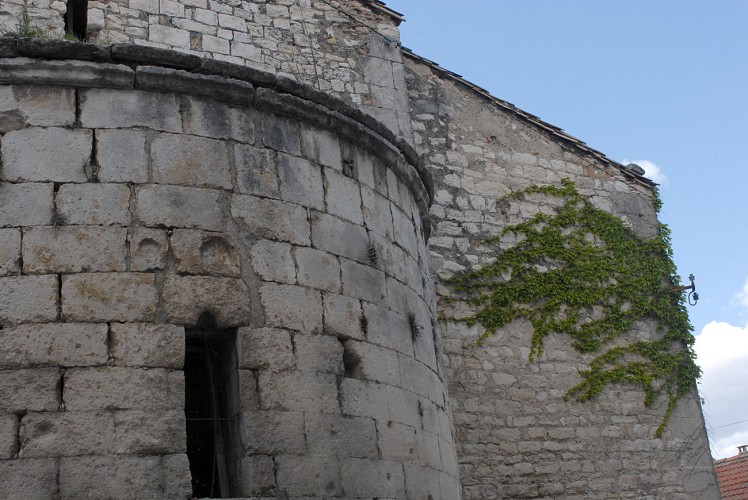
<box><xmin>0</xmin><ymin>57</ymin><xmax>135</xmax><ymax>89</ymax></box>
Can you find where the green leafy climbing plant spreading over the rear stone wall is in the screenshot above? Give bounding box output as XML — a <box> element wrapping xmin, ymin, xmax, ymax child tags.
<box><xmin>448</xmin><ymin>179</ymin><xmax>700</xmax><ymax>436</ymax></box>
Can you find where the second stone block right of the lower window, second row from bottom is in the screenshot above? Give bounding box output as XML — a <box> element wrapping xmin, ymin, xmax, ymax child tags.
<box><xmin>304</xmin><ymin>413</ymin><xmax>379</xmax><ymax>463</ymax></box>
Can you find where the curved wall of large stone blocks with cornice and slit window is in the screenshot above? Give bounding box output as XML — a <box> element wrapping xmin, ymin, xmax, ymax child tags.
<box><xmin>0</xmin><ymin>40</ymin><xmax>460</xmax><ymax>499</ymax></box>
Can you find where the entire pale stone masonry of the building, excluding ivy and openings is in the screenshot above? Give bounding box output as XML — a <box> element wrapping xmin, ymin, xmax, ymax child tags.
<box><xmin>0</xmin><ymin>0</ymin><xmax>719</xmax><ymax>500</ymax></box>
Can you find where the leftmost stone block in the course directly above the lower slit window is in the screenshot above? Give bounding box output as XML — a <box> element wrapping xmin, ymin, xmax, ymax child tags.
<box><xmin>0</xmin><ymin>275</ymin><xmax>58</xmax><ymax>326</ymax></box>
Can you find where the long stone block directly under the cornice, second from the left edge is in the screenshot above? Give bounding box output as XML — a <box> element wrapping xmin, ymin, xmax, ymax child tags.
<box><xmin>80</xmin><ymin>89</ymin><xmax>182</xmax><ymax>132</ymax></box>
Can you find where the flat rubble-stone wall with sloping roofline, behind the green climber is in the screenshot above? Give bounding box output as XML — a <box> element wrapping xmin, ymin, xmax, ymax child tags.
<box><xmin>407</xmin><ymin>55</ymin><xmax>719</xmax><ymax>500</ymax></box>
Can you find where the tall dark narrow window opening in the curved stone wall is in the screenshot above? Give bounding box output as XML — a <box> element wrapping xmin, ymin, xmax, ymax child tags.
<box><xmin>184</xmin><ymin>315</ymin><xmax>241</xmax><ymax>498</ymax></box>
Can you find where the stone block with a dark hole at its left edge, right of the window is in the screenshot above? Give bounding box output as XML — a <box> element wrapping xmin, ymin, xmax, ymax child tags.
<box><xmin>344</xmin><ymin>340</ymin><xmax>407</xmax><ymax>386</ymax></box>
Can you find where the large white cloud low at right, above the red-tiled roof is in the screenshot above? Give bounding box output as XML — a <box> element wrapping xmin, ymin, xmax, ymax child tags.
<box><xmin>694</xmin><ymin>321</ymin><xmax>748</xmax><ymax>458</ymax></box>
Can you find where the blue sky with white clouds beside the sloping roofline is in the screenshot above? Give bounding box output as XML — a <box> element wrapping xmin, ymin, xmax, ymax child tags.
<box><xmin>387</xmin><ymin>0</ymin><xmax>748</xmax><ymax>457</ymax></box>
